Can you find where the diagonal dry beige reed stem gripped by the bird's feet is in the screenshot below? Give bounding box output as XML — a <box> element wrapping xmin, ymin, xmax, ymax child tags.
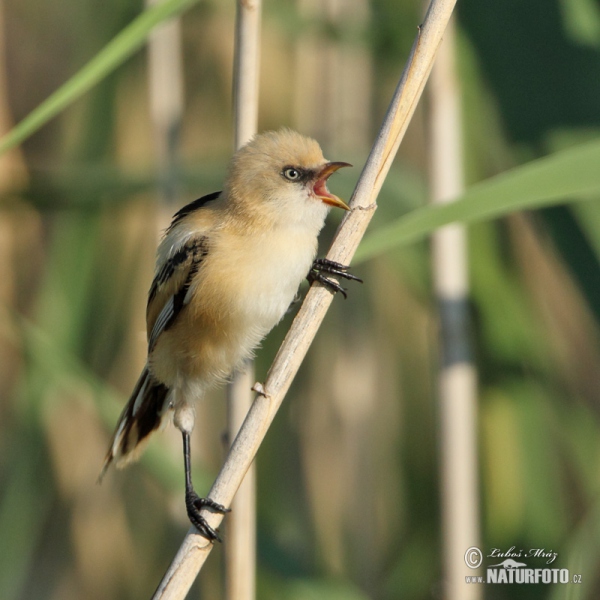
<box><xmin>153</xmin><ymin>0</ymin><xmax>456</xmax><ymax>600</ymax></box>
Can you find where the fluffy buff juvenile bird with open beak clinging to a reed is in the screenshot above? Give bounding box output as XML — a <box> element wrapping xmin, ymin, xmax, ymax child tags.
<box><xmin>101</xmin><ymin>130</ymin><xmax>360</xmax><ymax>540</ymax></box>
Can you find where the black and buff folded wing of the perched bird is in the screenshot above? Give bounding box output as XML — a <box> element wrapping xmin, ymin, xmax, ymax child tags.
<box><xmin>146</xmin><ymin>235</ymin><xmax>208</xmax><ymax>352</ymax></box>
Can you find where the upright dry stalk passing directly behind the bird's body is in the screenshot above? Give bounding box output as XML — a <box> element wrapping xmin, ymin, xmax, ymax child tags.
<box><xmin>225</xmin><ymin>0</ymin><xmax>261</xmax><ymax>600</ymax></box>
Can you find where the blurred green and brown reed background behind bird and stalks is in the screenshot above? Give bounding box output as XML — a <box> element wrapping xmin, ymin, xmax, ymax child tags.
<box><xmin>0</xmin><ymin>0</ymin><xmax>600</xmax><ymax>600</ymax></box>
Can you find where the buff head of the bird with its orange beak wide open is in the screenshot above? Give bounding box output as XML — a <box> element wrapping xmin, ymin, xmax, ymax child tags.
<box><xmin>228</xmin><ymin>129</ymin><xmax>351</xmax><ymax>226</ymax></box>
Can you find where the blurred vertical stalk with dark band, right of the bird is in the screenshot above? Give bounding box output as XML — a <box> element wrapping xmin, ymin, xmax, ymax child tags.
<box><xmin>429</xmin><ymin>22</ymin><xmax>481</xmax><ymax>600</ymax></box>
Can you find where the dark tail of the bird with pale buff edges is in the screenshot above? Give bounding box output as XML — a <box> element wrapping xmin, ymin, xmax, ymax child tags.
<box><xmin>98</xmin><ymin>367</ymin><xmax>169</xmax><ymax>481</ymax></box>
